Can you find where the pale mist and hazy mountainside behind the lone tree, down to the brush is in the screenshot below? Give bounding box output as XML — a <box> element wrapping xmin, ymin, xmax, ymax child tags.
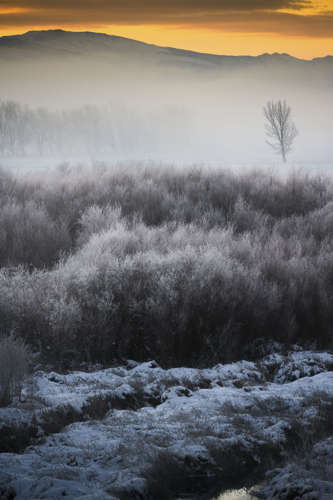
<box><xmin>0</xmin><ymin>31</ymin><xmax>333</xmax><ymax>164</ymax></box>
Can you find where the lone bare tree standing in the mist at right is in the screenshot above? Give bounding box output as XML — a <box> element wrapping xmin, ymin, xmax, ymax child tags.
<box><xmin>264</xmin><ymin>101</ymin><xmax>298</xmax><ymax>162</ymax></box>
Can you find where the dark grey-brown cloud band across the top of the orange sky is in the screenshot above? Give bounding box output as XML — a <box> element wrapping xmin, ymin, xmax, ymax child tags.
<box><xmin>0</xmin><ymin>0</ymin><xmax>333</xmax><ymax>37</ymax></box>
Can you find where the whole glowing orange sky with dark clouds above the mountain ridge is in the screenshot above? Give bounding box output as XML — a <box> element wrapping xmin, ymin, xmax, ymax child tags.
<box><xmin>0</xmin><ymin>0</ymin><xmax>333</xmax><ymax>59</ymax></box>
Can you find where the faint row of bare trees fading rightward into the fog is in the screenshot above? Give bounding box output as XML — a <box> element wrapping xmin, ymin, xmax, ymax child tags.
<box><xmin>0</xmin><ymin>101</ymin><xmax>187</xmax><ymax>157</ymax></box>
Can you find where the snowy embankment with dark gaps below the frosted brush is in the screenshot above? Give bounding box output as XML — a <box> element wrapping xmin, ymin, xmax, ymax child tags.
<box><xmin>0</xmin><ymin>350</ymin><xmax>333</xmax><ymax>500</ymax></box>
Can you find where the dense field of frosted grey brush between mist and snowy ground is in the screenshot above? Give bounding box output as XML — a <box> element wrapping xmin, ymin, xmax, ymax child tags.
<box><xmin>0</xmin><ymin>165</ymin><xmax>333</xmax><ymax>368</ymax></box>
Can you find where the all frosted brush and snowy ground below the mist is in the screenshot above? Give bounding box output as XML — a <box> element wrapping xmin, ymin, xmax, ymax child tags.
<box><xmin>0</xmin><ymin>164</ymin><xmax>333</xmax><ymax>500</ymax></box>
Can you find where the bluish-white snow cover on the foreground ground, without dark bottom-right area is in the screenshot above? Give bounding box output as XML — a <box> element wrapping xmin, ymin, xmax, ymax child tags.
<box><xmin>0</xmin><ymin>351</ymin><xmax>333</xmax><ymax>500</ymax></box>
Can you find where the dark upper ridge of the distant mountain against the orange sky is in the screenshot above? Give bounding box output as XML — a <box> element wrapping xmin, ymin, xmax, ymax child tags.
<box><xmin>0</xmin><ymin>30</ymin><xmax>333</xmax><ymax>70</ymax></box>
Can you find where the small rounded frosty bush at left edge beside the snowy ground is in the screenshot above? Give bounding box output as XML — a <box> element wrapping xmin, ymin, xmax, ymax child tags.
<box><xmin>0</xmin><ymin>335</ymin><xmax>29</xmax><ymax>406</ymax></box>
